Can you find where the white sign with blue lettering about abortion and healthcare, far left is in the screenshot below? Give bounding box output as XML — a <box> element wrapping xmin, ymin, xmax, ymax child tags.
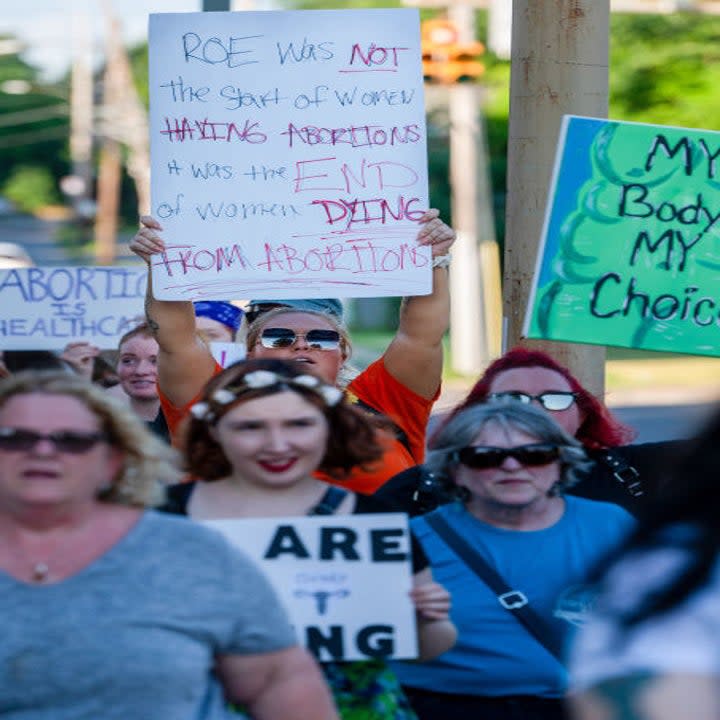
<box><xmin>0</xmin><ymin>267</ymin><xmax>147</xmax><ymax>350</ymax></box>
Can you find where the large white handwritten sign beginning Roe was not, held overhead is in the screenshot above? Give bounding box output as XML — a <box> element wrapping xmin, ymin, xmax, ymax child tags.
<box><xmin>149</xmin><ymin>9</ymin><xmax>431</xmax><ymax>299</ymax></box>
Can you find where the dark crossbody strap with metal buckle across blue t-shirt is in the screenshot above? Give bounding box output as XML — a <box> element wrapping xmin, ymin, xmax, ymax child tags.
<box><xmin>425</xmin><ymin>513</ymin><xmax>563</xmax><ymax>663</ymax></box>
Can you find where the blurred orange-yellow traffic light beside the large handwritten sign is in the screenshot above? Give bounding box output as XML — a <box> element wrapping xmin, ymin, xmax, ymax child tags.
<box><xmin>421</xmin><ymin>18</ymin><xmax>485</xmax><ymax>85</ymax></box>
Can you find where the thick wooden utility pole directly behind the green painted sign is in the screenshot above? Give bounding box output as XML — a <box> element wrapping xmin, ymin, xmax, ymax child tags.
<box><xmin>504</xmin><ymin>0</ymin><xmax>610</xmax><ymax>397</ymax></box>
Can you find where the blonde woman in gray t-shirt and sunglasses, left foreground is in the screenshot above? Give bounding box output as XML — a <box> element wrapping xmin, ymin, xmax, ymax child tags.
<box><xmin>0</xmin><ymin>373</ymin><xmax>337</xmax><ymax>720</ymax></box>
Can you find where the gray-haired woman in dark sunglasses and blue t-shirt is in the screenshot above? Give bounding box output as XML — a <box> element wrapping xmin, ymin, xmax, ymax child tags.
<box><xmin>390</xmin><ymin>402</ymin><xmax>633</xmax><ymax>720</ymax></box>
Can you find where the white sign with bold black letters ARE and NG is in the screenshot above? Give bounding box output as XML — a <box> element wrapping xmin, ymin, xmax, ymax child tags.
<box><xmin>207</xmin><ymin>513</ymin><xmax>417</xmax><ymax>661</ymax></box>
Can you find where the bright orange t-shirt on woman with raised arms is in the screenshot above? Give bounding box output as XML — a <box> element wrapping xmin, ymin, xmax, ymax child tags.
<box><xmin>158</xmin><ymin>358</ymin><xmax>440</xmax><ymax>495</ymax></box>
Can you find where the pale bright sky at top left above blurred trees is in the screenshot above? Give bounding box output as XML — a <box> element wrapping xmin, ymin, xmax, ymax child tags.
<box><xmin>0</xmin><ymin>0</ymin><xmax>268</xmax><ymax>80</ymax></box>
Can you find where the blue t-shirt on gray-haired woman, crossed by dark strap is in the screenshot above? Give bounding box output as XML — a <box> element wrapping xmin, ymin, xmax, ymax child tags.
<box><xmin>395</xmin><ymin>497</ymin><xmax>634</xmax><ymax>697</ymax></box>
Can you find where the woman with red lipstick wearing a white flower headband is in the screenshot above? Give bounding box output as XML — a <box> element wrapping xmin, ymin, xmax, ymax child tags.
<box><xmin>167</xmin><ymin>360</ymin><xmax>455</xmax><ymax>720</ymax></box>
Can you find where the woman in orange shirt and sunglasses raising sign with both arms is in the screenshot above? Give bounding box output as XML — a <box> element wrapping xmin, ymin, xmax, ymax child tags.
<box><xmin>130</xmin><ymin>210</ymin><xmax>455</xmax><ymax>494</ymax></box>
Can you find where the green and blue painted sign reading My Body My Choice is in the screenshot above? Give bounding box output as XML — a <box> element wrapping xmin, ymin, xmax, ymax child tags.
<box><xmin>525</xmin><ymin>116</ymin><xmax>720</xmax><ymax>356</ymax></box>
